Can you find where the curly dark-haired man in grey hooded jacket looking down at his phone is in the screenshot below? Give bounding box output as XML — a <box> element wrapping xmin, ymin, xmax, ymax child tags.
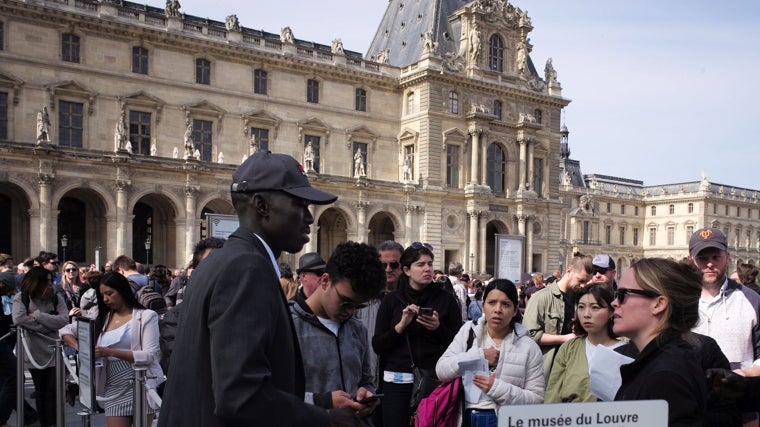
<box><xmin>288</xmin><ymin>241</ymin><xmax>384</xmax><ymax>417</ymax></box>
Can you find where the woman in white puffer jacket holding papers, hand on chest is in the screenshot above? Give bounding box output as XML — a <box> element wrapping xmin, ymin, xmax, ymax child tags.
<box><xmin>435</xmin><ymin>279</ymin><xmax>545</xmax><ymax>426</ymax></box>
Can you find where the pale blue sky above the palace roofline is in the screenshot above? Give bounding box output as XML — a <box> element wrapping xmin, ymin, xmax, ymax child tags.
<box><xmin>178</xmin><ymin>0</ymin><xmax>760</xmax><ymax>189</ymax></box>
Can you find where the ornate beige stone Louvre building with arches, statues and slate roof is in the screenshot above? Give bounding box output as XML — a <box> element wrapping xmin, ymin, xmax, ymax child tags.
<box><xmin>0</xmin><ymin>0</ymin><xmax>760</xmax><ymax>274</ymax></box>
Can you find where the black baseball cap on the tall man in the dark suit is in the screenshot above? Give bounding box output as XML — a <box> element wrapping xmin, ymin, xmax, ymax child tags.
<box><xmin>230</xmin><ymin>151</ymin><xmax>338</xmax><ymax>205</ymax></box>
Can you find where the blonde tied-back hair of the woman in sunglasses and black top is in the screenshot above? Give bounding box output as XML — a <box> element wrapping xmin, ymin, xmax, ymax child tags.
<box><xmin>631</xmin><ymin>258</ymin><xmax>702</xmax><ymax>333</ymax></box>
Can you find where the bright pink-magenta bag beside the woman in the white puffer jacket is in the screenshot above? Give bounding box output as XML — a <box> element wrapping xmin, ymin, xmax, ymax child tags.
<box><xmin>414</xmin><ymin>321</ymin><xmax>476</xmax><ymax>427</ymax></box>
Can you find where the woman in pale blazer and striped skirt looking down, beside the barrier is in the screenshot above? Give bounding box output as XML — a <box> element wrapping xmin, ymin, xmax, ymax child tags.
<box><xmin>60</xmin><ymin>272</ymin><xmax>163</xmax><ymax>427</ymax></box>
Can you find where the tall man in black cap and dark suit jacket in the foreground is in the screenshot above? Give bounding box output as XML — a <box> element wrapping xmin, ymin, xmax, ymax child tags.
<box><xmin>159</xmin><ymin>151</ymin><xmax>356</xmax><ymax>427</ymax></box>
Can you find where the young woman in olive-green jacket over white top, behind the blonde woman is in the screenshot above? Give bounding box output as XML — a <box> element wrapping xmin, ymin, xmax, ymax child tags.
<box><xmin>544</xmin><ymin>283</ymin><xmax>624</xmax><ymax>403</ymax></box>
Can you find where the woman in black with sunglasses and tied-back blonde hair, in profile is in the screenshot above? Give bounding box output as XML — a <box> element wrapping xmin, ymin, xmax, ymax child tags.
<box><xmin>612</xmin><ymin>258</ymin><xmax>707</xmax><ymax>427</ymax></box>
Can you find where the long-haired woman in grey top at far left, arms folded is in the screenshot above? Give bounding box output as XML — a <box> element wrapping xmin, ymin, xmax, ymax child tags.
<box><xmin>13</xmin><ymin>267</ymin><xmax>69</xmax><ymax>427</ymax></box>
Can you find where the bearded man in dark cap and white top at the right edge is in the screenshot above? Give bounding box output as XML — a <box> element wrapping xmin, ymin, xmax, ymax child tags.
<box><xmin>689</xmin><ymin>228</ymin><xmax>760</xmax><ymax>423</ymax></box>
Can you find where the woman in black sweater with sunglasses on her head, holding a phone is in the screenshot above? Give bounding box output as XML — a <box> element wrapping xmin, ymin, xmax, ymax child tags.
<box><xmin>372</xmin><ymin>242</ymin><xmax>462</xmax><ymax>427</ymax></box>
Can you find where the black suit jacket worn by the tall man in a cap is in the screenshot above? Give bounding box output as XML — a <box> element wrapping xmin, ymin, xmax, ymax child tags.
<box><xmin>158</xmin><ymin>228</ymin><xmax>329</xmax><ymax>427</ymax></box>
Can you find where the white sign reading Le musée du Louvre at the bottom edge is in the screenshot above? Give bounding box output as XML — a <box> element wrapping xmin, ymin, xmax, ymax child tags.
<box><xmin>499</xmin><ymin>400</ymin><xmax>668</xmax><ymax>427</ymax></box>
